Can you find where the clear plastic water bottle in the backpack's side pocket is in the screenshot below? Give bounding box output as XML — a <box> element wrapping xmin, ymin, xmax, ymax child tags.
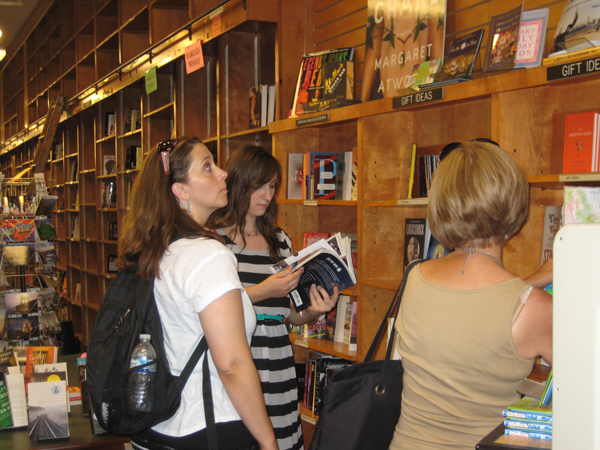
<box><xmin>127</xmin><ymin>334</ymin><xmax>156</xmax><ymax>412</ymax></box>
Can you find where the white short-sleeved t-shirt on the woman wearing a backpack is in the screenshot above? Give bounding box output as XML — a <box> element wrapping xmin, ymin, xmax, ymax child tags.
<box><xmin>152</xmin><ymin>238</ymin><xmax>256</xmax><ymax>436</ymax></box>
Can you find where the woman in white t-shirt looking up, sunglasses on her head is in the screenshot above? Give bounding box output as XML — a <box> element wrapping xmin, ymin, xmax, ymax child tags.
<box><xmin>117</xmin><ymin>138</ymin><xmax>278</xmax><ymax>450</ymax></box>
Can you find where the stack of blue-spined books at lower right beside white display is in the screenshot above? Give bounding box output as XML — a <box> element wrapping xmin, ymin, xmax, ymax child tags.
<box><xmin>502</xmin><ymin>370</ymin><xmax>552</xmax><ymax>440</ymax></box>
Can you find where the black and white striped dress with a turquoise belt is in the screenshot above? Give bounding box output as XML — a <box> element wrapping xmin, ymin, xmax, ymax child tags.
<box><xmin>218</xmin><ymin>228</ymin><xmax>304</xmax><ymax>450</ymax></box>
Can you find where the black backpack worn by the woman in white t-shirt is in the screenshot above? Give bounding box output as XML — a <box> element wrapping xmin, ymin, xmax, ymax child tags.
<box><xmin>86</xmin><ymin>270</ymin><xmax>212</xmax><ymax>435</ymax></box>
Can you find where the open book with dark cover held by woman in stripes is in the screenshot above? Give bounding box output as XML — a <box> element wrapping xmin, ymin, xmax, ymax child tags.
<box><xmin>271</xmin><ymin>233</ymin><xmax>356</xmax><ymax>311</ymax></box>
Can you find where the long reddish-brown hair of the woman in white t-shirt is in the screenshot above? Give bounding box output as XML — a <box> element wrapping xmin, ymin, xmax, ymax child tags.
<box><xmin>117</xmin><ymin>137</ymin><xmax>221</xmax><ymax>280</ymax></box>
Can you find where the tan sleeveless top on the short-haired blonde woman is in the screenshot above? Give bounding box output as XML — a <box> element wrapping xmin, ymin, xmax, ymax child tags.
<box><xmin>390</xmin><ymin>267</ymin><xmax>534</xmax><ymax>450</ymax></box>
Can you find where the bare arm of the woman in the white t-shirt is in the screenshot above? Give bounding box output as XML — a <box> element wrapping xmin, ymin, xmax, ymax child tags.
<box><xmin>199</xmin><ymin>290</ymin><xmax>278</xmax><ymax>450</ymax></box>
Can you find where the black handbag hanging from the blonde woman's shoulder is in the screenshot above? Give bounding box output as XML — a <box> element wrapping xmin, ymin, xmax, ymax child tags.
<box><xmin>309</xmin><ymin>261</ymin><xmax>420</xmax><ymax>450</ymax></box>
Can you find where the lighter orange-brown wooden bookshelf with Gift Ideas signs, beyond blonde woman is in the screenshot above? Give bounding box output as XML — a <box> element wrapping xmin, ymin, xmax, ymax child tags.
<box><xmin>270</xmin><ymin>67</ymin><xmax>600</xmax><ymax>366</ymax></box>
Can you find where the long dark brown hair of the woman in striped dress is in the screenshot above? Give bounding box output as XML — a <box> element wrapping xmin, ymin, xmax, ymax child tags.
<box><xmin>207</xmin><ymin>145</ymin><xmax>281</xmax><ymax>261</ymax></box>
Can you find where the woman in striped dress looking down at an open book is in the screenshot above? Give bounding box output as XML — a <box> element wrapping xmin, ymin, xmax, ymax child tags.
<box><xmin>209</xmin><ymin>146</ymin><xmax>338</xmax><ymax>450</ymax></box>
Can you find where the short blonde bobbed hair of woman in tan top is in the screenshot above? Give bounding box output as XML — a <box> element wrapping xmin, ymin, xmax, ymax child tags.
<box><xmin>428</xmin><ymin>141</ymin><xmax>529</xmax><ymax>248</ymax></box>
